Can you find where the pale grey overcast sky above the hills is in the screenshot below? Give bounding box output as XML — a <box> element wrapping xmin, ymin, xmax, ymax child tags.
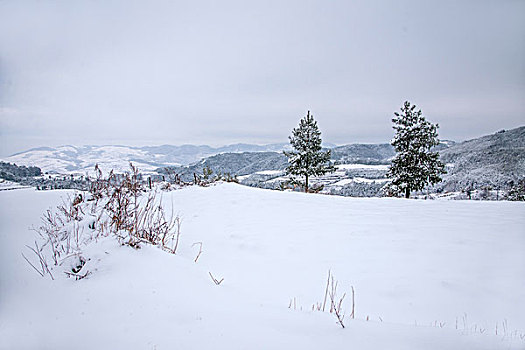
<box><xmin>0</xmin><ymin>0</ymin><xmax>525</xmax><ymax>156</ymax></box>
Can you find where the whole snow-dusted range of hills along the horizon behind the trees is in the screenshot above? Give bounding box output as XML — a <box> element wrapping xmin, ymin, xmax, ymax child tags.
<box><xmin>3</xmin><ymin>127</ymin><xmax>525</xmax><ymax>195</ymax></box>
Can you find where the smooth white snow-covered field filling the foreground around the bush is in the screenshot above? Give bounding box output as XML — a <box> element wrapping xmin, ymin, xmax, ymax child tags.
<box><xmin>0</xmin><ymin>184</ymin><xmax>525</xmax><ymax>349</ymax></box>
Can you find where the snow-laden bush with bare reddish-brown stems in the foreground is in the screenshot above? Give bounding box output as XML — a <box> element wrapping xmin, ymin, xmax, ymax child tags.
<box><xmin>22</xmin><ymin>164</ymin><xmax>181</xmax><ymax>279</ymax></box>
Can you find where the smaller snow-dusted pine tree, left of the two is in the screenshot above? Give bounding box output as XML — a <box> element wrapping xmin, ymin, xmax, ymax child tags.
<box><xmin>284</xmin><ymin>111</ymin><xmax>335</xmax><ymax>192</ymax></box>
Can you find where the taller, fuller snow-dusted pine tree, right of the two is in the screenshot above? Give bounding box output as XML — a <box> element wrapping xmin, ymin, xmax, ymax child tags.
<box><xmin>388</xmin><ymin>101</ymin><xmax>446</xmax><ymax>198</ymax></box>
